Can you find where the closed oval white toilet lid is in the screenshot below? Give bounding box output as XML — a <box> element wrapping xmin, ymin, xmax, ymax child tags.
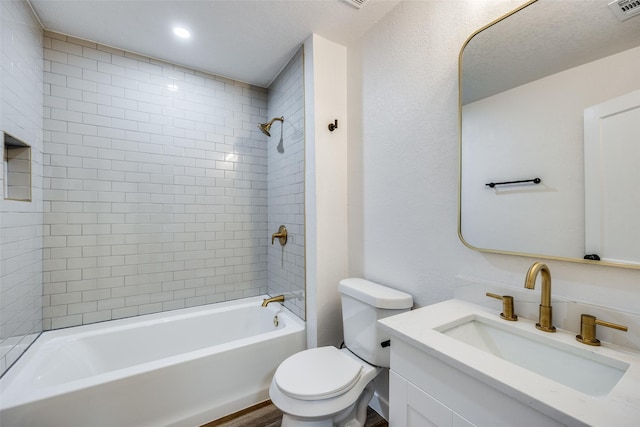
<box><xmin>274</xmin><ymin>347</ymin><xmax>362</xmax><ymax>400</ymax></box>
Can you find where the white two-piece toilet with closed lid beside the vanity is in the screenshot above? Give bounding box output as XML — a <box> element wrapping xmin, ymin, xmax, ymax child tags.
<box><xmin>269</xmin><ymin>278</ymin><xmax>413</xmax><ymax>427</ymax></box>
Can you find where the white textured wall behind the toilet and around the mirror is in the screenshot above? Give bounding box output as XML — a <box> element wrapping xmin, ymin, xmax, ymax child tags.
<box><xmin>348</xmin><ymin>0</ymin><xmax>640</xmax><ymax>313</ymax></box>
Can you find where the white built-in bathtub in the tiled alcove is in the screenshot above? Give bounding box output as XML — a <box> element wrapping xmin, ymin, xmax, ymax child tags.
<box><xmin>0</xmin><ymin>297</ymin><xmax>305</xmax><ymax>427</ymax></box>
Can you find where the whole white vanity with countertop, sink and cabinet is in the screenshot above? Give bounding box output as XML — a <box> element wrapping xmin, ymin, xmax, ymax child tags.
<box><xmin>379</xmin><ymin>299</ymin><xmax>640</xmax><ymax>427</ymax></box>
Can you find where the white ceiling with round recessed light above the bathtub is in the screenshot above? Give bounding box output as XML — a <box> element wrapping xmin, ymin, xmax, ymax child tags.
<box><xmin>30</xmin><ymin>0</ymin><xmax>399</xmax><ymax>87</ymax></box>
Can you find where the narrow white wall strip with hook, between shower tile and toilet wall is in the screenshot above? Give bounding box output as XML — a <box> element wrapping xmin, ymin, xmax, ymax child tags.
<box><xmin>304</xmin><ymin>35</ymin><xmax>348</xmax><ymax>347</ymax></box>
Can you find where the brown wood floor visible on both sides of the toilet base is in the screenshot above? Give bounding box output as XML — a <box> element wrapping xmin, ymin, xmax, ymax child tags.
<box><xmin>202</xmin><ymin>400</ymin><xmax>389</xmax><ymax>427</ymax></box>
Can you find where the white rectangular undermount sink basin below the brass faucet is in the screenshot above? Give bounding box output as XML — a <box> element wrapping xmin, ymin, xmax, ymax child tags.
<box><xmin>436</xmin><ymin>316</ymin><xmax>629</xmax><ymax>396</ymax></box>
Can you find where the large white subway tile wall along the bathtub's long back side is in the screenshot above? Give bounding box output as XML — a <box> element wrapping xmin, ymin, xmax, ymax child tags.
<box><xmin>43</xmin><ymin>32</ymin><xmax>304</xmax><ymax>329</ymax></box>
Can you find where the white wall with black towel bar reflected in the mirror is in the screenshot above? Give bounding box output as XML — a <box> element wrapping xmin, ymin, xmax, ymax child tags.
<box><xmin>462</xmin><ymin>47</ymin><xmax>640</xmax><ymax>258</ymax></box>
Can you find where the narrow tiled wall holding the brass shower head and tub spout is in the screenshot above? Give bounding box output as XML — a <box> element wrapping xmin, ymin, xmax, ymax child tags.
<box><xmin>267</xmin><ymin>48</ymin><xmax>305</xmax><ymax>319</ymax></box>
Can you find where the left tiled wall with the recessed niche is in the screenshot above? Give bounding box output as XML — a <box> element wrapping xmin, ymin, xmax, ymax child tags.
<box><xmin>0</xmin><ymin>0</ymin><xmax>43</xmax><ymax>375</ymax></box>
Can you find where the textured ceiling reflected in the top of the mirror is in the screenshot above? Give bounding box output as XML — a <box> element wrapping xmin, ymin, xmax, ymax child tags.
<box><xmin>462</xmin><ymin>0</ymin><xmax>640</xmax><ymax>104</ymax></box>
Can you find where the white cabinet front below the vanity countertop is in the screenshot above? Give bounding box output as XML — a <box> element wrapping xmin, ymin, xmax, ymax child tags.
<box><xmin>389</xmin><ymin>339</ymin><xmax>564</xmax><ymax>427</ymax></box>
